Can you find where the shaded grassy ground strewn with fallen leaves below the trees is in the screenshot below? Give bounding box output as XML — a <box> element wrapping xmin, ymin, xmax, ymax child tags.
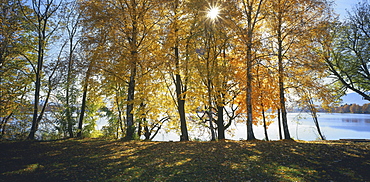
<box><xmin>0</xmin><ymin>139</ymin><xmax>370</xmax><ymax>181</ymax></box>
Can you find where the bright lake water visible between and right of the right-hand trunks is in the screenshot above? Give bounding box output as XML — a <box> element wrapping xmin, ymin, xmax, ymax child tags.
<box><xmin>154</xmin><ymin>113</ymin><xmax>370</xmax><ymax>141</ymax></box>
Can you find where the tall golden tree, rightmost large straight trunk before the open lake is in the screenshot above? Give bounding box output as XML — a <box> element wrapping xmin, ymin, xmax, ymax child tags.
<box><xmin>266</xmin><ymin>0</ymin><xmax>328</xmax><ymax>139</ymax></box>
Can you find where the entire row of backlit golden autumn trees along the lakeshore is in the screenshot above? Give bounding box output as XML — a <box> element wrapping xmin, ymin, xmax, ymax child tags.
<box><xmin>0</xmin><ymin>0</ymin><xmax>370</xmax><ymax>141</ymax></box>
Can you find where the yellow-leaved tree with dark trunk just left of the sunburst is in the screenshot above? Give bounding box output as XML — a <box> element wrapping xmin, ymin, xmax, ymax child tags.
<box><xmin>164</xmin><ymin>0</ymin><xmax>207</xmax><ymax>141</ymax></box>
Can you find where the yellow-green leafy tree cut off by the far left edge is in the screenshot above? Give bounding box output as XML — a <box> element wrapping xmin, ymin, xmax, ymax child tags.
<box><xmin>0</xmin><ymin>1</ymin><xmax>33</xmax><ymax>138</ymax></box>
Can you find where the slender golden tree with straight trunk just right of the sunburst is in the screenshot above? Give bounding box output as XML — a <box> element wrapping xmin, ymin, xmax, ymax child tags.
<box><xmin>225</xmin><ymin>0</ymin><xmax>266</xmax><ymax>140</ymax></box>
